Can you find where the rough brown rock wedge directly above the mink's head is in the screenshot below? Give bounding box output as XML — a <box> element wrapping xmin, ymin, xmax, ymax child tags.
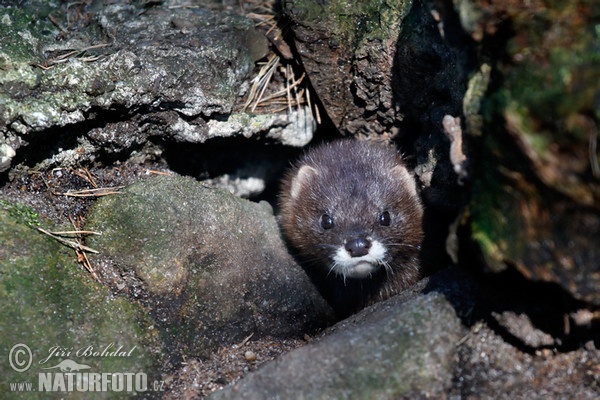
<box><xmin>284</xmin><ymin>0</ymin><xmax>411</xmax><ymax>134</ymax></box>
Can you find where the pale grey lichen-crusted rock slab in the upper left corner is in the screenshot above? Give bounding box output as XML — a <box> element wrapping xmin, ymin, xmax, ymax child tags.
<box><xmin>2</xmin><ymin>5</ymin><xmax>253</xmax><ymax>132</ymax></box>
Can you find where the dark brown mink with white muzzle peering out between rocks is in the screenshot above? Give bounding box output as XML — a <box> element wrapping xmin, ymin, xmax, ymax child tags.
<box><xmin>279</xmin><ymin>140</ymin><xmax>423</xmax><ymax>317</ymax></box>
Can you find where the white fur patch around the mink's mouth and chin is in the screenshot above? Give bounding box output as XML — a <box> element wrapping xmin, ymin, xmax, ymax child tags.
<box><xmin>332</xmin><ymin>240</ymin><xmax>386</xmax><ymax>279</ymax></box>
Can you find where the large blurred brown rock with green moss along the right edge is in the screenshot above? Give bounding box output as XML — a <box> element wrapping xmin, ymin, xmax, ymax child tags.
<box><xmin>459</xmin><ymin>1</ymin><xmax>600</xmax><ymax>307</ymax></box>
